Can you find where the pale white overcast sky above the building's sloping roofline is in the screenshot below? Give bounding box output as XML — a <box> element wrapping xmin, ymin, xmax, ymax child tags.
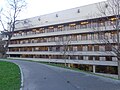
<box><xmin>0</xmin><ymin>0</ymin><xmax>106</xmax><ymax>31</ymax></box>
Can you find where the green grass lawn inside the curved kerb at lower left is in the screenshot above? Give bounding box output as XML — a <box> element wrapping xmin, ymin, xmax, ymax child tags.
<box><xmin>0</xmin><ymin>61</ymin><xmax>21</xmax><ymax>90</ymax></box>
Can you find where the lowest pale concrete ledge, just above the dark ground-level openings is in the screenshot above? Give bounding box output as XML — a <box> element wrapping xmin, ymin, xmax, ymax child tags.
<box><xmin>9</xmin><ymin>56</ymin><xmax>118</xmax><ymax>66</ymax></box>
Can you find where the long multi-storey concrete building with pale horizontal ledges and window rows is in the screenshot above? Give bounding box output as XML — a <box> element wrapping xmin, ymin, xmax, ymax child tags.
<box><xmin>4</xmin><ymin>2</ymin><xmax>118</xmax><ymax>74</ymax></box>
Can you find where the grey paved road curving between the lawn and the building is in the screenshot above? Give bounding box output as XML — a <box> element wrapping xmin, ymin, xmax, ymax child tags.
<box><xmin>6</xmin><ymin>60</ymin><xmax>120</xmax><ymax>90</ymax></box>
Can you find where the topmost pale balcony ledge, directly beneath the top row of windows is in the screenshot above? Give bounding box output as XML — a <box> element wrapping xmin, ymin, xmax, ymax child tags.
<box><xmin>4</xmin><ymin>26</ymin><xmax>114</xmax><ymax>40</ymax></box>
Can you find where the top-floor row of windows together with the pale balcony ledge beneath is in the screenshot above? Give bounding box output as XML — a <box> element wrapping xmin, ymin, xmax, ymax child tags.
<box><xmin>5</xmin><ymin>21</ymin><xmax>115</xmax><ymax>38</ymax></box>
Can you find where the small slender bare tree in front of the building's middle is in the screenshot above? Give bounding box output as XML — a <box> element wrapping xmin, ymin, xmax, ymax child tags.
<box><xmin>56</xmin><ymin>37</ymin><xmax>71</xmax><ymax>66</ymax></box>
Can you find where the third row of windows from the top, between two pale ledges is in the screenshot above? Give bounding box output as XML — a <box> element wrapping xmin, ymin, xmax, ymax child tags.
<box><xmin>9</xmin><ymin>44</ymin><xmax>115</xmax><ymax>52</ymax></box>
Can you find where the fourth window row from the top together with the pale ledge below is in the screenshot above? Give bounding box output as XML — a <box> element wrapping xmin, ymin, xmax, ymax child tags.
<box><xmin>8</xmin><ymin>53</ymin><xmax>117</xmax><ymax>66</ymax></box>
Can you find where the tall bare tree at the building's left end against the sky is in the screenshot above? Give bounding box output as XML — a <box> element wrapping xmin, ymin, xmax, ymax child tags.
<box><xmin>0</xmin><ymin>0</ymin><xmax>26</xmax><ymax>55</ymax></box>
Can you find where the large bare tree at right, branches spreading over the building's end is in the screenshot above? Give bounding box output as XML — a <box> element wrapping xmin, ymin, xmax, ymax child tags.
<box><xmin>92</xmin><ymin>0</ymin><xmax>120</xmax><ymax>79</ymax></box>
